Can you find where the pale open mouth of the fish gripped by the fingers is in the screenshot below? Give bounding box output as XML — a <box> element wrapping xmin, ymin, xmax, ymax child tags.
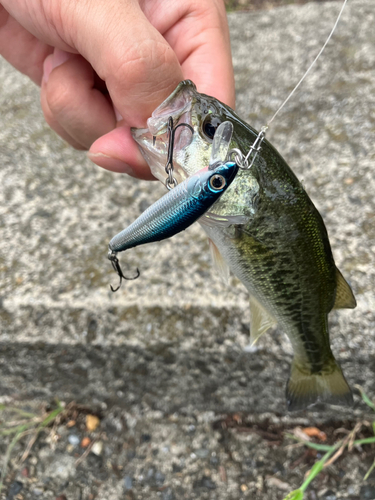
<box><xmin>131</xmin><ymin>80</ymin><xmax>197</xmax><ymax>183</ymax></box>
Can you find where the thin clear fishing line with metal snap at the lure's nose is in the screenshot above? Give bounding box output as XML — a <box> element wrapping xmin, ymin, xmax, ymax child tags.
<box><xmin>235</xmin><ymin>0</ymin><xmax>348</xmax><ymax>170</ymax></box>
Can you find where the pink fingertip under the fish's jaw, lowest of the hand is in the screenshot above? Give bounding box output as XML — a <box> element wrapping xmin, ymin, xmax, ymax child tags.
<box><xmin>88</xmin><ymin>126</ymin><xmax>154</xmax><ymax>180</ymax></box>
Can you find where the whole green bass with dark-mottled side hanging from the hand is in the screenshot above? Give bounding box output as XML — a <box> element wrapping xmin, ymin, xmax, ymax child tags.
<box><xmin>132</xmin><ymin>80</ymin><xmax>356</xmax><ymax>411</ymax></box>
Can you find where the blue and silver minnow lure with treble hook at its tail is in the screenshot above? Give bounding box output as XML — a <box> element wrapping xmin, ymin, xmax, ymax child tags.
<box><xmin>108</xmin><ymin>162</ymin><xmax>238</xmax><ymax>292</ymax></box>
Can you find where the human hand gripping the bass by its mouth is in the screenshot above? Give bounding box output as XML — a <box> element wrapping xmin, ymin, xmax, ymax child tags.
<box><xmin>0</xmin><ymin>0</ymin><xmax>234</xmax><ymax>179</ymax></box>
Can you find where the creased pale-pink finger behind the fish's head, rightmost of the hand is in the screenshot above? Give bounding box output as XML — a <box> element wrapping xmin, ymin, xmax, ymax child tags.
<box><xmin>145</xmin><ymin>0</ymin><xmax>235</xmax><ymax>107</ymax></box>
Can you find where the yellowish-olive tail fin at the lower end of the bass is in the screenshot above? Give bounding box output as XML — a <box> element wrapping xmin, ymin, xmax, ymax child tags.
<box><xmin>286</xmin><ymin>358</ymin><xmax>353</xmax><ymax>411</ymax></box>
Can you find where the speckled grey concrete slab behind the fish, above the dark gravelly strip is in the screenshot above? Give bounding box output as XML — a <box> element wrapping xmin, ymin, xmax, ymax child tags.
<box><xmin>0</xmin><ymin>0</ymin><xmax>375</xmax><ymax>499</ymax></box>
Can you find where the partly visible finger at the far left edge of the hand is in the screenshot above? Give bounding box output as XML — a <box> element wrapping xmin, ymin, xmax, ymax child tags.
<box><xmin>0</xmin><ymin>5</ymin><xmax>53</xmax><ymax>85</ymax></box>
